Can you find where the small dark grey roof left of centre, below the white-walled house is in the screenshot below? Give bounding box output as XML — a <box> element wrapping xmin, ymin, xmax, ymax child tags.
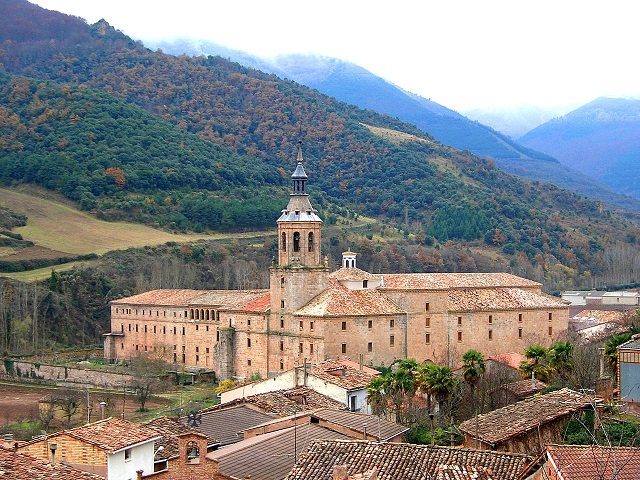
<box><xmin>195</xmin><ymin>405</ymin><xmax>273</xmax><ymax>446</ymax></box>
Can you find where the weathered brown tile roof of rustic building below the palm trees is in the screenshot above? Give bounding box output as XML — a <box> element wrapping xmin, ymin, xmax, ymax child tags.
<box><xmin>459</xmin><ymin>388</ymin><xmax>596</xmax><ymax>445</ymax></box>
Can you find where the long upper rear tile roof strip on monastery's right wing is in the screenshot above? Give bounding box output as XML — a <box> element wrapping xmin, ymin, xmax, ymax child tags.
<box><xmin>380</xmin><ymin>273</ymin><xmax>542</xmax><ymax>290</ymax></box>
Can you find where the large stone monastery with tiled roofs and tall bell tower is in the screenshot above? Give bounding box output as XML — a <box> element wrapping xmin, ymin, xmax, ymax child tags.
<box><xmin>104</xmin><ymin>146</ymin><xmax>568</xmax><ymax>380</ymax></box>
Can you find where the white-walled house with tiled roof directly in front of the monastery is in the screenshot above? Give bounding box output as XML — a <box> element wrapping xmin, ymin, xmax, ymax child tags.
<box><xmin>220</xmin><ymin>359</ymin><xmax>380</xmax><ymax>413</ymax></box>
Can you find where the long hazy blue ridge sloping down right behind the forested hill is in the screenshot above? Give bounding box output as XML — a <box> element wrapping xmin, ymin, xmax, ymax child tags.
<box><xmin>144</xmin><ymin>38</ymin><xmax>640</xmax><ymax>211</ymax></box>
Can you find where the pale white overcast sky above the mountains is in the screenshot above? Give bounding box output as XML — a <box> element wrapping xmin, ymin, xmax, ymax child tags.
<box><xmin>32</xmin><ymin>0</ymin><xmax>640</xmax><ymax>111</ymax></box>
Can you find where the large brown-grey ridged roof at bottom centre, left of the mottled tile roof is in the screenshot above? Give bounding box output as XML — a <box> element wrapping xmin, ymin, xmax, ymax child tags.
<box><xmin>207</xmin><ymin>424</ymin><xmax>349</xmax><ymax>480</ymax></box>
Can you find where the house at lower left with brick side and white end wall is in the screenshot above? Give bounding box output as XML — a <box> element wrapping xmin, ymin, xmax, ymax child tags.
<box><xmin>18</xmin><ymin>418</ymin><xmax>162</xmax><ymax>479</ymax></box>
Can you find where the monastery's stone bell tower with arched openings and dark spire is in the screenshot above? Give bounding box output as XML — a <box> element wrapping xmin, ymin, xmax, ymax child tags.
<box><xmin>270</xmin><ymin>142</ymin><xmax>329</xmax><ymax>316</ymax></box>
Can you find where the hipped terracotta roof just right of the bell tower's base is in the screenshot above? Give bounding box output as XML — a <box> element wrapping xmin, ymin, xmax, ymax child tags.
<box><xmin>295</xmin><ymin>278</ymin><xmax>405</xmax><ymax>317</ymax></box>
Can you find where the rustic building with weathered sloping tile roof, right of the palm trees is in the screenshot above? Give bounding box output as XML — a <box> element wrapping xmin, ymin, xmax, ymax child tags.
<box><xmin>459</xmin><ymin>388</ymin><xmax>601</xmax><ymax>456</ymax></box>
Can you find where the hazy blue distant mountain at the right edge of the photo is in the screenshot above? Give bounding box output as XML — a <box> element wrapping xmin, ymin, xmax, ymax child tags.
<box><xmin>519</xmin><ymin>98</ymin><xmax>640</xmax><ymax>198</ymax></box>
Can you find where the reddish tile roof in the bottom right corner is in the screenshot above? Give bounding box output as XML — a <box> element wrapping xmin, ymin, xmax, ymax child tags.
<box><xmin>547</xmin><ymin>445</ymin><xmax>640</xmax><ymax>480</ymax></box>
